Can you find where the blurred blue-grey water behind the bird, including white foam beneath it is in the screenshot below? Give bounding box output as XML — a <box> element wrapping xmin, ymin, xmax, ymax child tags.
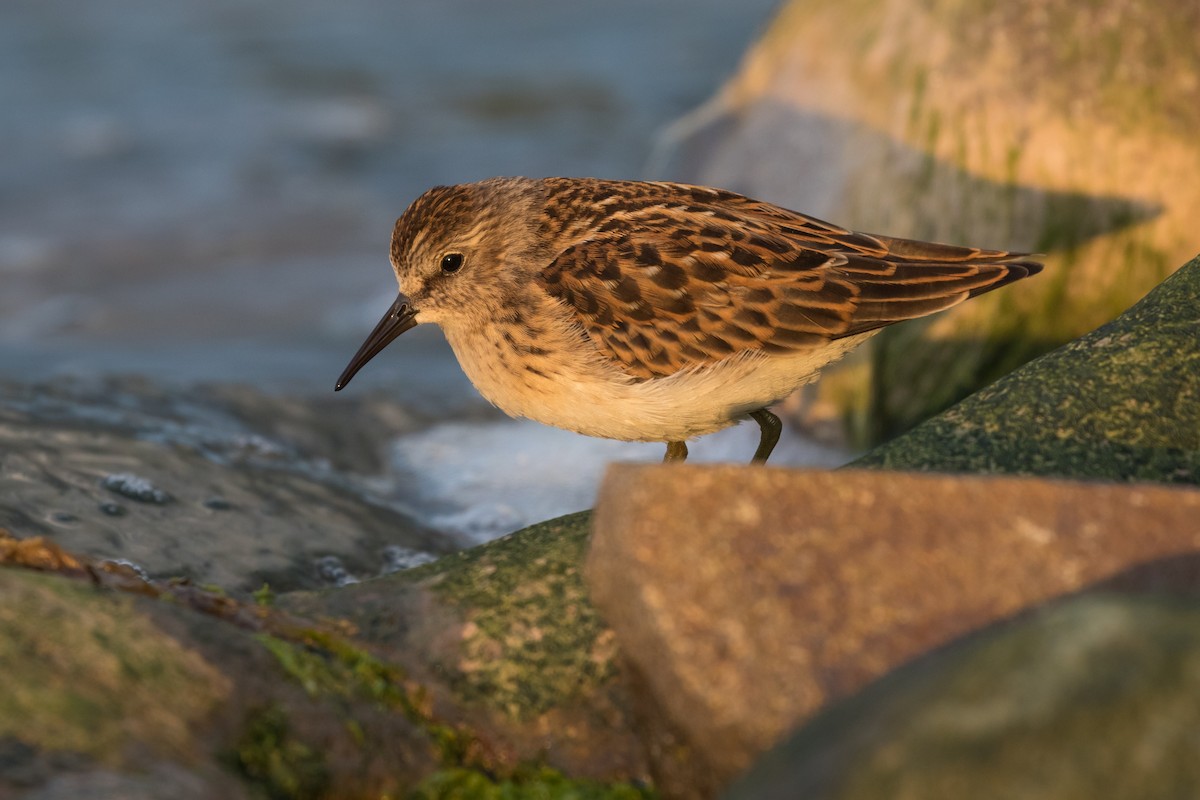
<box><xmin>0</xmin><ymin>0</ymin><xmax>836</xmax><ymax>575</ymax></box>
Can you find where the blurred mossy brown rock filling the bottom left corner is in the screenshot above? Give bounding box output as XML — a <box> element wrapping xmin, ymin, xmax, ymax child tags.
<box><xmin>0</xmin><ymin>537</ymin><xmax>457</xmax><ymax>798</ymax></box>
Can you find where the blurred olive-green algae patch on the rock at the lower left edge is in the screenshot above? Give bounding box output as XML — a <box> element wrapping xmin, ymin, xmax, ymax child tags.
<box><xmin>0</xmin><ymin>569</ymin><xmax>232</xmax><ymax>766</ymax></box>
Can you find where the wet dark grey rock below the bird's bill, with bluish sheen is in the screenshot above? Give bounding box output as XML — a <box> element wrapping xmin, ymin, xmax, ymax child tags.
<box><xmin>0</xmin><ymin>378</ymin><xmax>454</xmax><ymax>591</ymax></box>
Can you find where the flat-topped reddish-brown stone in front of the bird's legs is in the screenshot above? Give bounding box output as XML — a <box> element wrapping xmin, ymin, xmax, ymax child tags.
<box><xmin>588</xmin><ymin>465</ymin><xmax>1200</xmax><ymax>796</ymax></box>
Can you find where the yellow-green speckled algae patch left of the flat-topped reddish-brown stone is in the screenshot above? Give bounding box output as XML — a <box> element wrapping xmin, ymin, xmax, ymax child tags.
<box><xmin>295</xmin><ymin>512</ymin><xmax>616</xmax><ymax>721</ymax></box>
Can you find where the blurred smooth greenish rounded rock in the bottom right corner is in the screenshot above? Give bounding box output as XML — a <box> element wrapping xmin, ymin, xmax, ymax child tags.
<box><xmin>725</xmin><ymin>597</ymin><xmax>1200</xmax><ymax>800</ymax></box>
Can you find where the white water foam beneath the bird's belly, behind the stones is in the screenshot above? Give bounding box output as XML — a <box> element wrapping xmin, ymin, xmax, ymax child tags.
<box><xmin>391</xmin><ymin>420</ymin><xmax>848</xmax><ymax>546</ymax></box>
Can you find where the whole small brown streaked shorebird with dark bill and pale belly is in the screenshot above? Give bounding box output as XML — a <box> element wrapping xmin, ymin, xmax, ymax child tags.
<box><xmin>337</xmin><ymin>178</ymin><xmax>1042</xmax><ymax>461</ymax></box>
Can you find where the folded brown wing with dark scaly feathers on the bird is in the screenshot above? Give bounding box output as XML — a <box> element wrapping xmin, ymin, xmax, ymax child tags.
<box><xmin>538</xmin><ymin>184</ymin><xmax>1042</xmax><ymax>379</ymax></box>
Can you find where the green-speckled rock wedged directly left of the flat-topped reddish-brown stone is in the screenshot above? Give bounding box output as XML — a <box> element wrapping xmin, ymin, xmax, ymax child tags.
<box><xmin>280</xmin><ymin>512</ymin><xmax>647</xmax><ymax>780</ymax></box>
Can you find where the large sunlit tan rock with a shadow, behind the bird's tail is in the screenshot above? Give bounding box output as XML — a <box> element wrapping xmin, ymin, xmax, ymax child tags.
<box><xmin>653</xmin><ymin>0</ymin><xmax>1200</xmax><ymax>444</ymax></box>
